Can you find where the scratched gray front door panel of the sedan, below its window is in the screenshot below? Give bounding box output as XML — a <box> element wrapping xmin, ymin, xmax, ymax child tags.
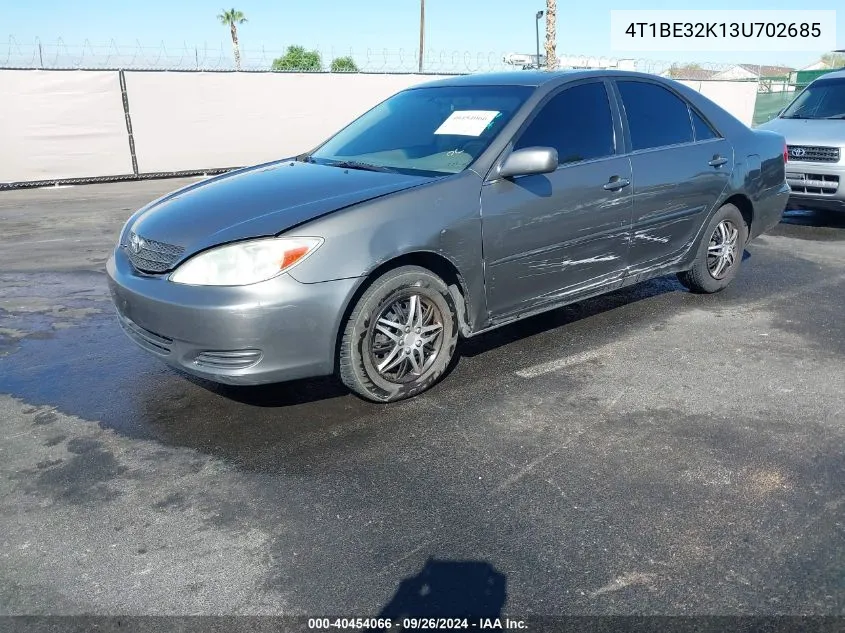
<box><xmin>481</xmin><ymin>157</ymin><xmax>632</xmax><ymax>319</ymax></box>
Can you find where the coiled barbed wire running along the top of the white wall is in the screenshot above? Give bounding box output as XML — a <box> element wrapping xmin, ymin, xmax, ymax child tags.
<box><xmin>0</xmin><ymin>36</ymin><xmax>792</xmax><ymax>80</ymax></box>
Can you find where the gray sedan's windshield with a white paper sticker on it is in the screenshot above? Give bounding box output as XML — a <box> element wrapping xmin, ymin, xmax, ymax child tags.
<box><xmin>303</xmin><ymin>86</ymin><xmax>534</xmax><ymax>176</ymax></box>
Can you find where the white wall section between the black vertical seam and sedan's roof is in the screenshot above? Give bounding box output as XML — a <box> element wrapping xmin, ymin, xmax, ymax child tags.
<box><xmin>126</xmin><ymin>71</ymin><xmax>454</xmax><ymax>173</ymax></box>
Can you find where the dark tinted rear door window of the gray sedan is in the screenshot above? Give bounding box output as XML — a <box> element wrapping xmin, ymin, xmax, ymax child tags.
<box><xmin>617</xmin><ymin>81</ymin><xmax>693</xmax><ymax>150</ymax></box>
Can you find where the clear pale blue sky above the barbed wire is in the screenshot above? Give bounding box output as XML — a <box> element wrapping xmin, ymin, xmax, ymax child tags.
<box><xmin>0</xmin><ymin>0</ymin><xmax>845</xmax><ymax>67</ymax></box>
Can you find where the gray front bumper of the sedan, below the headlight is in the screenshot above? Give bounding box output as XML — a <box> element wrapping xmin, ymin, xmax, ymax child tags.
<box><xmin>106</xmin><ymin>247</ymin><xmax>358</xmax><ymax>385</ymax></box>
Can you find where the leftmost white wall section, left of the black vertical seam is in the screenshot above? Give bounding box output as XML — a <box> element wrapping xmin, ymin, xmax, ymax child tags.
<box><xmin>0</xmin><ymin>70</ymin><xmax>132</xmax><ymax>182</ymax></box>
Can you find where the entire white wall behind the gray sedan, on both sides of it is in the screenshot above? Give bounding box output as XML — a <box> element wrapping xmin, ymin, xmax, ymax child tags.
<box><xmin>0</xmin><ymin>70</ymin><xmax>757</xmax><ymax>183</ymax></box>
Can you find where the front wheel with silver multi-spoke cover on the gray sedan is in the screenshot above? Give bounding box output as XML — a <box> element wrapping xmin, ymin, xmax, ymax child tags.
<box><xmin>338</xmin><ymin>266</ymin><xmax>458</xmax><ymax>402</ymax></box>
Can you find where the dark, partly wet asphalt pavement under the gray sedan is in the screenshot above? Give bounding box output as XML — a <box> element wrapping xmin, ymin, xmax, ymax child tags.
<box><xmin>0</xmin><ymin>181</ymin><xmax>845</xmax><ymax>617</ymax></box>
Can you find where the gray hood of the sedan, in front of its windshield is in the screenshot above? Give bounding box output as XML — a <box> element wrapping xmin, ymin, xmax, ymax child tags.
<box><xmin>129</xmin><ymin>160</ymin><xmax>432</xmax><ymax>259</ymax></box>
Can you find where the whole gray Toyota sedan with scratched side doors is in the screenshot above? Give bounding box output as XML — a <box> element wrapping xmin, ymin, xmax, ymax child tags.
<box><xmin>107</xmin><ymin>71</ymin><xmax>789</xmax><ymax>402</ymax></box>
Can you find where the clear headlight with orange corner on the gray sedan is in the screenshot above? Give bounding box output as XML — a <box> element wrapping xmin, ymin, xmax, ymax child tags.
<box><xmin>170</xmin><ymin>237</ymin><xmax>323</xmax><ymax>286</ymax></box>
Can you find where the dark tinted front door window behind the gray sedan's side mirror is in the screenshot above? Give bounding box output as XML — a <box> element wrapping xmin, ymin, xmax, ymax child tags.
<box><xmin>514</xmin><ymin>82</ymin><xmax>616</xmax><ymax>165</ymax></box>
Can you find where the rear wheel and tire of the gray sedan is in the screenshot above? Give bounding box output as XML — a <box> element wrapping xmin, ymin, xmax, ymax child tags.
<box><xmin>678</xmin><ymin>204</ymin><xmax>748</xmax><ymax>294</ymax></box>
